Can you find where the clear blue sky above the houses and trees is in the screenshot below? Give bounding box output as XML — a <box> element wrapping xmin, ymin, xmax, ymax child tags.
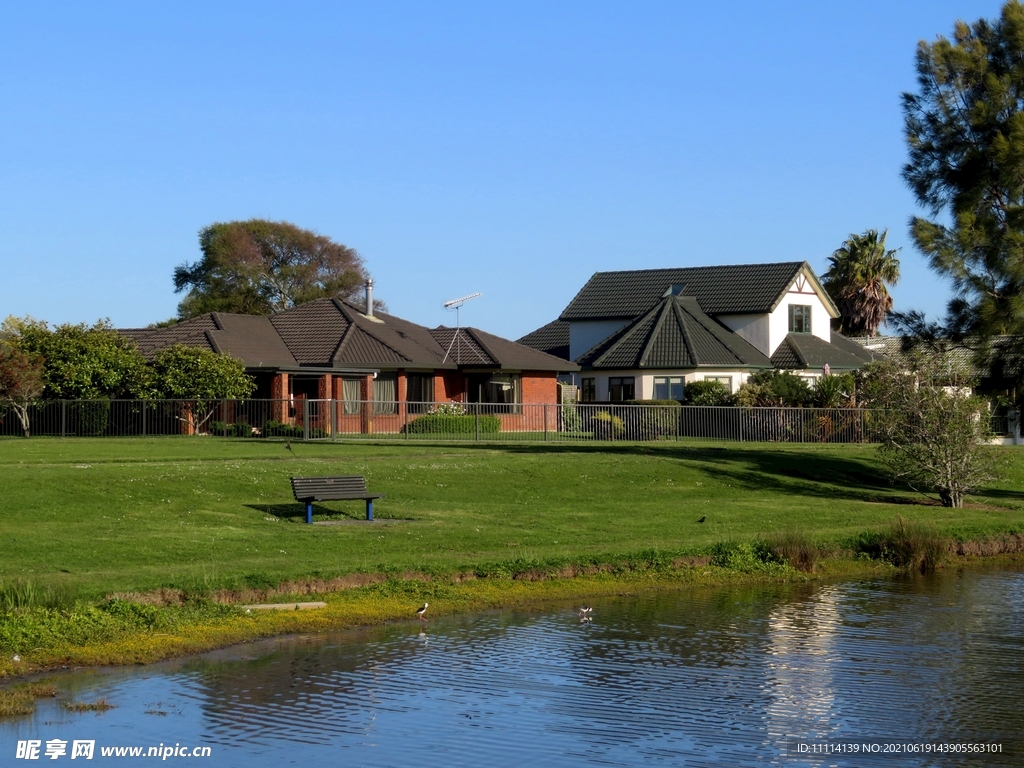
<box><xmin>0</xmin><ymin>0</ymin><xmax>1000</xmax><ymax>338</ymax></box>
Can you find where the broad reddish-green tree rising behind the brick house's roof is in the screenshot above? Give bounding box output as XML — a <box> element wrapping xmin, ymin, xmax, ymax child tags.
<box><xmin>174</xmin><ymin>219</ymin><xmax>368</xmax><ymax>319</ymax></box>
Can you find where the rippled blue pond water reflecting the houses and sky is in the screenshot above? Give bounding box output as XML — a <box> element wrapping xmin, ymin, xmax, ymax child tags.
<box><xmin>0</xmin><ymin>571</ymin><xmax>1024</xmax><ymax>766</ymax></box>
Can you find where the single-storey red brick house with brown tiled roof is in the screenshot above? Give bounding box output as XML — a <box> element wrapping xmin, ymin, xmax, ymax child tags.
<box><xmin>121</xmin><ymin>288</ymin><xmax>579</xmax><ymax>433</ymax></box>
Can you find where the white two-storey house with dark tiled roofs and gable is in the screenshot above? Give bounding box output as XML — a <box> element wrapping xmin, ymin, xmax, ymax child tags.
<box><xmin>519</xmin><ymin>261</ymin><xmax>873</xmax><ymax>401</ymax></box>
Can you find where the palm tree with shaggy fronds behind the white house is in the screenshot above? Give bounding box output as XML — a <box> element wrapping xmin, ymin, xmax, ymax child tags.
<box><xmin>821</xmin><ymin>229</ymin><xmax>899</xmax><ymax>336</ymax></box>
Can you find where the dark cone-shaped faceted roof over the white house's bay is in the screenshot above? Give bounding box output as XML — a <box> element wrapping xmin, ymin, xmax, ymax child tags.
<box><xmin>578</xmin><ymin>296</ymin><xmax>771</xmax><ymax>370</ymax></box>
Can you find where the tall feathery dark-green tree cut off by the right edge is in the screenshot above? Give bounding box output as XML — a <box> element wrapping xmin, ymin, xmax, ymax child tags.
<box><xmin>901</xmin><ymin>0</ymin><xmax>1024</xmax><ymax>391</ymax></box>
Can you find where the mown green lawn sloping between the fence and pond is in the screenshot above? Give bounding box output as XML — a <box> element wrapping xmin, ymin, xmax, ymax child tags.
<box><xmin>0</xmin><ymin>437</ymin><xmax>1024</xmax><ymax>595</ymax></box>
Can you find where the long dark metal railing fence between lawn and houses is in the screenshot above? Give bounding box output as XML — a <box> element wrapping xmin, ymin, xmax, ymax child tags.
<box><xmin>0</xmin><ymin>398</ymin><xmax>991</xmax><ymax>442</ymax></box>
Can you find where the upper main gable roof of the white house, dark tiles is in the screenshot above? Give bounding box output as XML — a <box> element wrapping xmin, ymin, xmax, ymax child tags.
<box><xmin>559</xmin><ymin>261</ymin><xmax>827</xmax><ymax>321</ymax></box>
